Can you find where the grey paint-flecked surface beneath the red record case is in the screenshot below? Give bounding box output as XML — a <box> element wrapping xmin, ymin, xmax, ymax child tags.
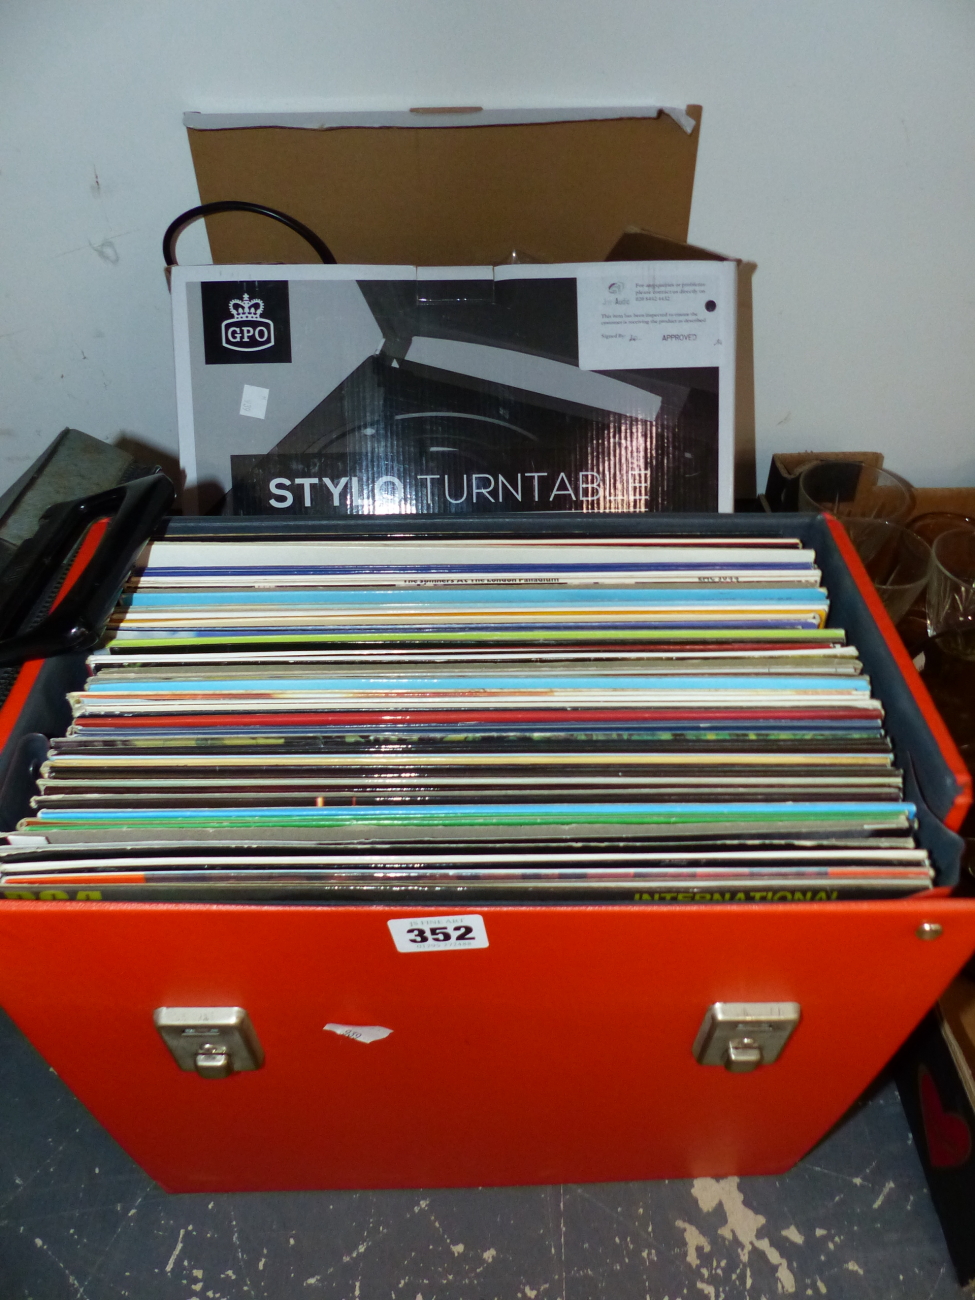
<box><xmin>0</xmin><ymin>1014</ymin><xmax>963</xmax><ymax>1300</ymax></box>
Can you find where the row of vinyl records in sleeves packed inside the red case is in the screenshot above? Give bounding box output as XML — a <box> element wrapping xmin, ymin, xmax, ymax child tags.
<box><xmin>0</xmin><ymin>537</ymin><xmax>933</xmax><ymax>904</ymax></box>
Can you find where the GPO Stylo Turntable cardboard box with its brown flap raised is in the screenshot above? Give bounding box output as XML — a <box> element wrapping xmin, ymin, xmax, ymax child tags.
<box><xmin>173</xmin><ymin>108</ymin><xmax>737</xmax><ymax>517</ymax></box>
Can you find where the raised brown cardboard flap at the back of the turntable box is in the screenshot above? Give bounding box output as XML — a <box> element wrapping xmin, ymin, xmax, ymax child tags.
<box><xmin>186</xmin><ymin>105</ymin><xmax>701</xmax><ymax>267</ymax></box>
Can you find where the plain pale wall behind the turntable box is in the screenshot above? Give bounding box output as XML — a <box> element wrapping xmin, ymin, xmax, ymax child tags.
<box><xmin>0</xmin><ymin>0</ymin><xmax>975</xmax><ymax>488</ymax></box>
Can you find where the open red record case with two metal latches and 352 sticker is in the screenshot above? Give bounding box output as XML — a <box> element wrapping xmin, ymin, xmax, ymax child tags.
<box><xmin>0</xmin><ymin>515</ymin><xmax>975</xmax><ymax>1192</ymax></box>
